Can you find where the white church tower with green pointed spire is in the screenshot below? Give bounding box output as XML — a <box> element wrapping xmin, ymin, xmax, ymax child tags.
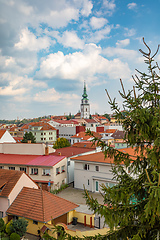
<box><xmin>81</xmin><ymin>81</ymin><xmax>90</xmax><ymax>119</ymax></box>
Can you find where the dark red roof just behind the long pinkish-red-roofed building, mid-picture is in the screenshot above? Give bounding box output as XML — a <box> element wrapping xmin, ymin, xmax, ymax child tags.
<box><xmin>50</xmin><ymin>147</ymin><xmax>93</xmax><ymax>157</ymax></box>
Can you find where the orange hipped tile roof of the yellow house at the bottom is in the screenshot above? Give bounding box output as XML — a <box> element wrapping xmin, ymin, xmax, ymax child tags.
<box><xmin>7</xmin><ymin>187</ymin><xmax>78</xmax><ymax>222</ymax></box>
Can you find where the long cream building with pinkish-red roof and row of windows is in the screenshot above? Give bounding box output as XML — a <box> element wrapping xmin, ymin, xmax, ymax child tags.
<box><xmin>0</xmin><ymin>153</ymin><xmax>67</xmax><ymax>190</ymax></box>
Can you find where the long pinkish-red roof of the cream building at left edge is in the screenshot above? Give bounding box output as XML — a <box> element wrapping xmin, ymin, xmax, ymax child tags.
<box><xmin>0</xmin><ymin>153</ymin><xmax>64</xmax><ymax>166</ymax></box>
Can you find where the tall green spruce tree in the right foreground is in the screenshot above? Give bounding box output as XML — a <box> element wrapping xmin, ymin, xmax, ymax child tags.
<box><xmin>85</xmin><ymin>39</ymin><xmax>160</xmax><ymax>240</ymax></box>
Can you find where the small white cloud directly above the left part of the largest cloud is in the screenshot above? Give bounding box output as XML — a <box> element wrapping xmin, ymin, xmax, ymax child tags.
<box><xmin>54</xmin><ymin>31</ymin><xmax>84</xmax><ymax>49</ymax></box>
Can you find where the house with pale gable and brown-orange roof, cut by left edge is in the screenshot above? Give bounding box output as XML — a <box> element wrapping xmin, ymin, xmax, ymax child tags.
<box><xmin>0</xmin><ymin>169</ymin><xmax>38</xmax><ymax>218</ymax></box>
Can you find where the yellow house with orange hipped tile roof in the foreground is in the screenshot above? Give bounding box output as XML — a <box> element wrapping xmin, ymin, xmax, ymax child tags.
<box><xmin>7</xmin><ymin>187</ymin><xmax>79</xmax><ymax>235</ymax></box>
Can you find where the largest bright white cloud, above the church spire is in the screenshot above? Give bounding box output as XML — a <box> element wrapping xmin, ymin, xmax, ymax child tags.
<box><xmin>36</xmin><ymin>44</ymin><xmax>130</xmax><ymax>83</ymax></box>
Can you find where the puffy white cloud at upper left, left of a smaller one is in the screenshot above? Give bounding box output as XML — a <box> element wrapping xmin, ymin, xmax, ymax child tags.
<box><xmin>15</xmin><ymin>28</ymin><xmax>50</xmax><ymax>51</ymax></box>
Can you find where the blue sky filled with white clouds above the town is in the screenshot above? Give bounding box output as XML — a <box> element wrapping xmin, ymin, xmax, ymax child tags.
<box><xmin>0</xmin><ymin>0</ymin><xmax>160</xmax><ymax>120</ymax></box>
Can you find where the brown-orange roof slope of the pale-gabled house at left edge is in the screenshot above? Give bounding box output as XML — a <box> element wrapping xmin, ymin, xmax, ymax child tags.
<box><xmin>0</xmin><ymin>169</ymin><xmax>23</xmax><ymax>197</ymax></box>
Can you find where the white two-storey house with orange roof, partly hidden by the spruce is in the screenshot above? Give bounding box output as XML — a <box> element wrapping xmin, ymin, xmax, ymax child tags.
<box><xmin>71</xmin><ymin>148</ymin><xmax>135</xmax><ymax>192</ymax></box>
